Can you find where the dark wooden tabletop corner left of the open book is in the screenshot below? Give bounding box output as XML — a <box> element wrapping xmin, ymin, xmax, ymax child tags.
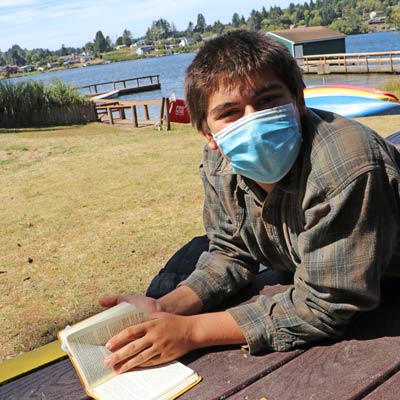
<box><xmin>0</xmin><ymin>360</ymin><xmax>89</xmax><ymax>400</ymax></box>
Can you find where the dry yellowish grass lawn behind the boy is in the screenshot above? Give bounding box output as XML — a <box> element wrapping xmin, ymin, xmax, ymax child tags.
<box><xmin>0</xmin><ymin>115</ymin><xmax>400</xmax><ymax>361</ymax></box>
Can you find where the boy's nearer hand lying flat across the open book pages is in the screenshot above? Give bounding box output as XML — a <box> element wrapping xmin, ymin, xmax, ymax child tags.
<box><xmin>104</xmin><ymin>312</ymin><xmax>198</xmax><ymax>373</ymax></box>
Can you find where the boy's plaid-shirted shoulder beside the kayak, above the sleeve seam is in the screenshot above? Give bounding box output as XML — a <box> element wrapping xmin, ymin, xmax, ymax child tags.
<box><xmin>304</xmin><ymin>109</ymin><xmax>399</xmax><ymax>196</ymax></box>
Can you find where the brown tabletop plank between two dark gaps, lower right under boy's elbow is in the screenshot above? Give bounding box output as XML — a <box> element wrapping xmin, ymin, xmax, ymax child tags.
<box><xmin>229</xmin><ymin>288</ymin><xmax>400</xmax><ymax>400</ymax></box>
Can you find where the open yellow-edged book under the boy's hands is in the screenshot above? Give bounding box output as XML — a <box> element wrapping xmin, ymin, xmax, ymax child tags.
<box><xmin>58</xmin><ymin>303</ymin><xmax>201</xmax><ymax>400</ymax></box>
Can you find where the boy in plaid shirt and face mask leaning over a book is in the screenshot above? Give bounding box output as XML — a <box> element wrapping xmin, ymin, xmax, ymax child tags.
<box><xmin>101</xmin><ymin>31</ymin><xmax>400</xmax><ymax>372</ymax></box>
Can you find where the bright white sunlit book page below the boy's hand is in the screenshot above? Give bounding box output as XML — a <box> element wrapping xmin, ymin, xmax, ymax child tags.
<box><xmin>94</xmin><ymin>361</ymin><xmax>198</xmax><ymax>400</ymax></box>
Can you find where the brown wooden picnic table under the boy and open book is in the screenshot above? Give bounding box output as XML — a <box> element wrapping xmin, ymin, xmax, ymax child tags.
<box><xmin>0</xmin><ymin>271</ymin><xmax>400</xmax><ymax>400</ymax></box>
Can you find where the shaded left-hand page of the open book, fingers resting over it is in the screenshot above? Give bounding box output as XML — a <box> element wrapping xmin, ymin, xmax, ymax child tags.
<box><xmin>63</xmin><ymin>307</ymin><xmax>147</xmax><ymax>390</ymax></box>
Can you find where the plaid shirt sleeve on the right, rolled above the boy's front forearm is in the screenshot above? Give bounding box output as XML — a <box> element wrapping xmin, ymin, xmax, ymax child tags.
<box><xmin>229</xmin><ymin>168</ymin><xmax>399</xmax><ymax>353</ymax></box>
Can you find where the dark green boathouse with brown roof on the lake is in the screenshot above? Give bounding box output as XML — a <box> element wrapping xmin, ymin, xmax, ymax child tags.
<box><xmin>267</xmin><ymin>26</ymin><xmax>346</xmax><ymax>57</ymax></box>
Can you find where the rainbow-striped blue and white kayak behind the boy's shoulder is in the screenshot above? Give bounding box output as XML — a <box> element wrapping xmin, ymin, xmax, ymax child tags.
<box><xmin>304</xmin><ymin>84</ymin><xmax>400</xmax><ymax>118</ymax></box>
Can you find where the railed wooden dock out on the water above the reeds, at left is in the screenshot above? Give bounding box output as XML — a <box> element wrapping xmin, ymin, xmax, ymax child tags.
<box><xmin>77</xmin><ymin>75</ymin><xmax>161</xmax><ymax>98</ymax></box>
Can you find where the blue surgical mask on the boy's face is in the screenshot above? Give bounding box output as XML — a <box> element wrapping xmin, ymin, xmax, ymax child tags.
<box><xmin>214</xmin><ymin>103</ymin><xmax>302</xmax><ymax>183</ymax></box>
